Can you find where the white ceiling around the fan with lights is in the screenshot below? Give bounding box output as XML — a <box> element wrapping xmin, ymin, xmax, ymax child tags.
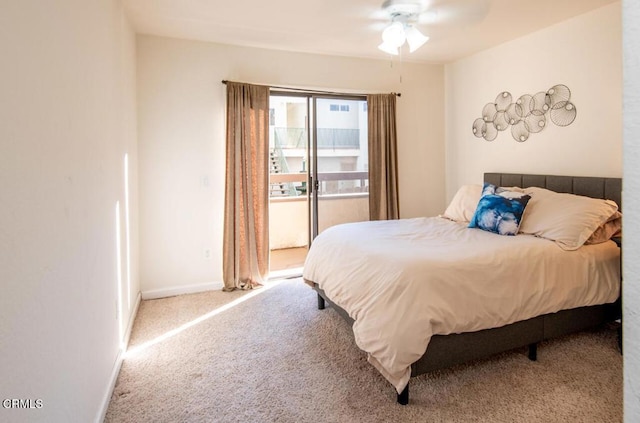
<box><xmin>123</xmin><ymin>0</ymin><xmax>619</xmax><ymax>63</ymax></box>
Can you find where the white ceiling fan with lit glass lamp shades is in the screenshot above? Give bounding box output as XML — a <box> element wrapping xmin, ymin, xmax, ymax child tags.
<box><xmin>378</xmin><ymin>0</ymin><xmax>489</xmax><ymax>56</ymax></box>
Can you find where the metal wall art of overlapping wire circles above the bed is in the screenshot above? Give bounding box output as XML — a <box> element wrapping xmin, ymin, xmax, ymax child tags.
<box><xmin>472</xmin><ymin>84</ymin><xmax>577</xmax><ymax>142</ymax></box>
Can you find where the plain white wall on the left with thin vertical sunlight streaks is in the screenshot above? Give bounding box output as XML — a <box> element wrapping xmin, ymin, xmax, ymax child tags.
<box><xmin>0</xmin><ymin>0</ymin><xmax>139</xmax><ymax>422</ymax></box>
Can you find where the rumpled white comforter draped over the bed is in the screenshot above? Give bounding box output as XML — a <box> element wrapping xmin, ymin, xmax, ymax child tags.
<box><xmin>303</xmin><ymin>217</ymin><xmax>620</xmax><ymax>392</ymax></box>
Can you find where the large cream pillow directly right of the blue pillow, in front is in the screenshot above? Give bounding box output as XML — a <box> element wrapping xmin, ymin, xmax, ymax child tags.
<box><xmin>520</xmin><ymin>187</ymin><xmax>618</xmax><ymax>251</ymax></box>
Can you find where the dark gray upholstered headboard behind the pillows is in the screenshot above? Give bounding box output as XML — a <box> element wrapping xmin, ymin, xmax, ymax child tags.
<box><xmin>484</xmin><ymin>173</ymin><xmax>622</xmax><ymax>210</ymax></box>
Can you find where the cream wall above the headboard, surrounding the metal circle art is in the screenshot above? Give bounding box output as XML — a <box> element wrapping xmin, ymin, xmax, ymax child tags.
<box><xmin>446</xmin><ymin>2</ymin><xmax>622</xmax><ymax>199</ymax></box>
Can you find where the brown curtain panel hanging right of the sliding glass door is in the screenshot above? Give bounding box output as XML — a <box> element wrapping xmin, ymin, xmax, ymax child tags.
<box><xmin>367</xmin><ymin>94</ymin><xmax>400</xmax><ymax>220</ymax></box>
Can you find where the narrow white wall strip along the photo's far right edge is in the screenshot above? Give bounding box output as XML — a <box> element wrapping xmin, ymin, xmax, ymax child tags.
<box><xmin>622</xmin><ymin>1</ymin><xmax>640</xmax><ymax>423</ymax></box>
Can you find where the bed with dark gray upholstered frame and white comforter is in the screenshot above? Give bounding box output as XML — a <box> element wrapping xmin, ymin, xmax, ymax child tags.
<box><xmin>303</xmin><ymin>173</ymin><xmax>622</xmax><ymax>405</ymax></box>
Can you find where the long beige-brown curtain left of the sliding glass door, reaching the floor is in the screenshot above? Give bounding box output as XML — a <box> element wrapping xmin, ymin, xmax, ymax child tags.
<box><xmin>223</xmin><ymin>82</ymin><xmax>269</xmax><ymax>291</ymax></box>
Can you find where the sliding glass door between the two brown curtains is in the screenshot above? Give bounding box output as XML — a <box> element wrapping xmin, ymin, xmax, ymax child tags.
<box><xmin>269</xmin><ymin>93</ymin><xmax>369</xmax><ymax>270</ymax></box>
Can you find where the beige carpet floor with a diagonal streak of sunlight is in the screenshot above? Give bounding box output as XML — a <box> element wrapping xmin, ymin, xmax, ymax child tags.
<box><xmin>106</xmin><ymin>279</ymin><xmax>622</xmax><ymax>423</ymax></box>
